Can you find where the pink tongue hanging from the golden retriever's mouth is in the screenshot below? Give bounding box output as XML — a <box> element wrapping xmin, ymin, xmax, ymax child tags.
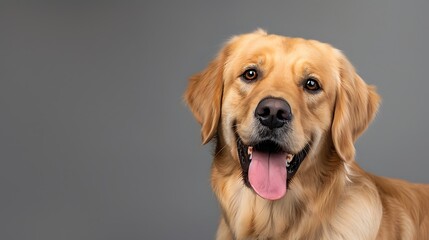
<box><xmin>249</xmin><ymin>150</ymin><xmax>287</xmax><ymax>200</ymax></box>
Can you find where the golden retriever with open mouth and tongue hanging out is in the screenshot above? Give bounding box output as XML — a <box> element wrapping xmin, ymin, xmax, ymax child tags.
<box><xmin>184</xmin><ymin>30</ymin><xmax>429</xmax><ymax>240</ymax></box>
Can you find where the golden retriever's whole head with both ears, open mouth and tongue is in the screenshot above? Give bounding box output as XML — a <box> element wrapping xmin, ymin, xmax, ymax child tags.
<box><xmin>185</xmin><ymin>30</ymin><xmax>379</xmax><ymax>200</ymax></box>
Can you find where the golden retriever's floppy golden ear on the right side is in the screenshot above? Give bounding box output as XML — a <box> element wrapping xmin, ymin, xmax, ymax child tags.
<box><xmin>332</xmin><ymin>51</ymin><xmax>380</xmax><ymax>161</ymax></box>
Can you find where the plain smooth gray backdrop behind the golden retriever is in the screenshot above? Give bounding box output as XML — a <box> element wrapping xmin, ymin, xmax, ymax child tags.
<box><xmin>0</xmin><ymin>0</ymin><xmax>429</xmax><ymax>240</ymax></box>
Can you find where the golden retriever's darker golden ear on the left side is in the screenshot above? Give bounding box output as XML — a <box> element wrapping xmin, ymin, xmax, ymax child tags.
<box><xmin>184</xmin><ymin>48</ymin><xmax>226</xmax><ymax>144</ymax></box>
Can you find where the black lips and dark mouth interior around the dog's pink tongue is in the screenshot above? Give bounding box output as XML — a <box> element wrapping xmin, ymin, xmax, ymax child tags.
<box><xmin>234</xmin><ymin>125</ymin><xmax>311</xmax><ymax>188</ymax></box>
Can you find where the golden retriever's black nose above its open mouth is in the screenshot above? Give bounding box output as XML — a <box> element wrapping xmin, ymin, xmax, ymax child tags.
<box><xmin>255</xmin><ymin>97</ymin><xmax>292</xmax><ymax>129</ymax></box>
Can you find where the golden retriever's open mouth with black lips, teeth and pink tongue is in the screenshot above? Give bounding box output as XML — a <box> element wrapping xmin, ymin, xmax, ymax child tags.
<box><xmin>237</xmin><ymin>136</ymin><xmax>310</xmax><ymax>200</ymax></box>
